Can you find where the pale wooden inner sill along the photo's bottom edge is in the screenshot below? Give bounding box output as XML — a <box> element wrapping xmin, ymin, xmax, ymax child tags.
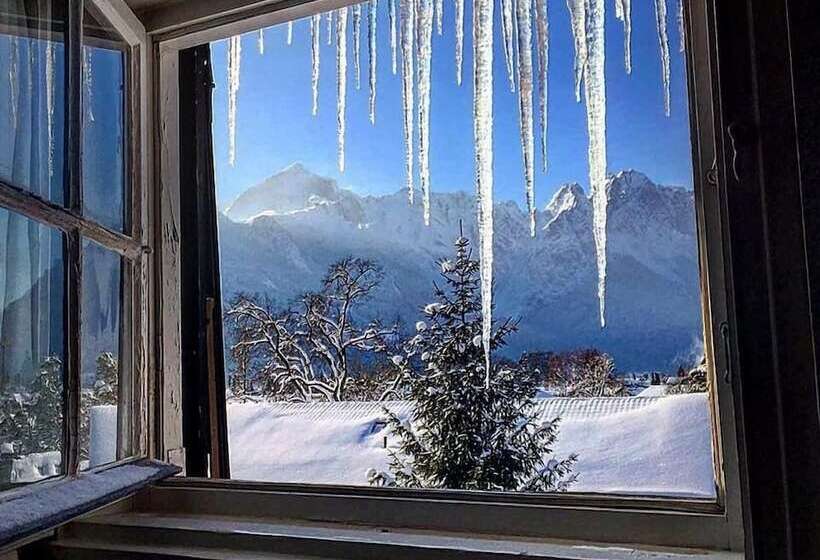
<box><xmin>53</xmin><ymin>511</ymin><xmax>742</xmax><ymax>560</ymax></box>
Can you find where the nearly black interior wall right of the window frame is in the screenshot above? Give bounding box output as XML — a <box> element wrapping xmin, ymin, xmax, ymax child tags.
<box><xmin>715</xmin><ymin>0</ymin><xmax>820</xmax><ymax>560</ymax></box>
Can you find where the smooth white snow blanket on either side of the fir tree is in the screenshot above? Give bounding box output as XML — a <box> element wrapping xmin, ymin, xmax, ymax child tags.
<box><xmin>228</xmin><ymin>393</ymin><xmax>715</xmax><ymax>498</ymax></box>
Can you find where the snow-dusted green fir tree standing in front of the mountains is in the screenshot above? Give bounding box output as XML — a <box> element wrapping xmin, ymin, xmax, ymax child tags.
<box><xmin>376</xmin><ymin>231</ymin><xmax>576</xmax><ymax>492</ymax></box>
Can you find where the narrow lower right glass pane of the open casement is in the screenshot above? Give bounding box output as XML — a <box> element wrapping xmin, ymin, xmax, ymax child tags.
<box><xmin>80</xmin><ymin>241</ymin><xmax>126</xmax><ymax>468</ymax></box>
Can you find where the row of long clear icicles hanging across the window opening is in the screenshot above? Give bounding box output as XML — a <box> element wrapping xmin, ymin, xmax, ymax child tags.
<box><xmin>223</xmin><ymin>0</ymin><xmax>684</xmax><ymax>382</ymax></box>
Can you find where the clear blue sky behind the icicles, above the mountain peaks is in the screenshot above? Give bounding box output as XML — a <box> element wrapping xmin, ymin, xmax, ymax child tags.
<box><xmin>212</xmin><ymin>0</ymin><xmax>692</xmax><ymax>207</ymax></box>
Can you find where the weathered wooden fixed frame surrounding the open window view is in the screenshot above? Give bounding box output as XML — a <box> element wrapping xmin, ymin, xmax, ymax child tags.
<box><xmin>151</xmin><ymin>0</ymin><xmax>744</xmax><ymax>551</ymax></box>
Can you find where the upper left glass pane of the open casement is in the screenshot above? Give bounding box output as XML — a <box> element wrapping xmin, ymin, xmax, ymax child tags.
<box><xmin>0</xmin><ymin>0</ymin><xmax>65</xmax><ymax>204</ymax></box>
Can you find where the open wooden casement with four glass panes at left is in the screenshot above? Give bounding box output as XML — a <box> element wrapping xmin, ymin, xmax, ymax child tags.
<box><xmin>0</xmin><ymin>0</ymin><xmax>147</xmax><ymax>489</ymax></box>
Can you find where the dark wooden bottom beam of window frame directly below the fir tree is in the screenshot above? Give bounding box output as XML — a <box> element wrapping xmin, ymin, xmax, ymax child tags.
<box><xmin>137</xmin><ymin>477</ymin><xmax>743</xmax><ymax>557</ymax></box>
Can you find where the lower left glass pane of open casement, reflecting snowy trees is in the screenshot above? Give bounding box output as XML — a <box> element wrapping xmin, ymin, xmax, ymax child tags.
<box><xmin>0</xmin><ymin>209</ymin><xmax>65</xmax><ymax>489</ymax></box>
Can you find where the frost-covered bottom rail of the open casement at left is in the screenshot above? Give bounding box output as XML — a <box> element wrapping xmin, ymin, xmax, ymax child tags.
<box><xmin>0</xmin><ymin>459</ymin><xmax>179</xmax><ymax>553</ymax></box>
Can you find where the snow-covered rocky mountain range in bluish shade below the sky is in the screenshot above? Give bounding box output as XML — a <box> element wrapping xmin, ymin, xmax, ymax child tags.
<box><xmin>219</xmin><ymin>164</ymin><xmax>701</xmax><ymax>370</ymax></box>
